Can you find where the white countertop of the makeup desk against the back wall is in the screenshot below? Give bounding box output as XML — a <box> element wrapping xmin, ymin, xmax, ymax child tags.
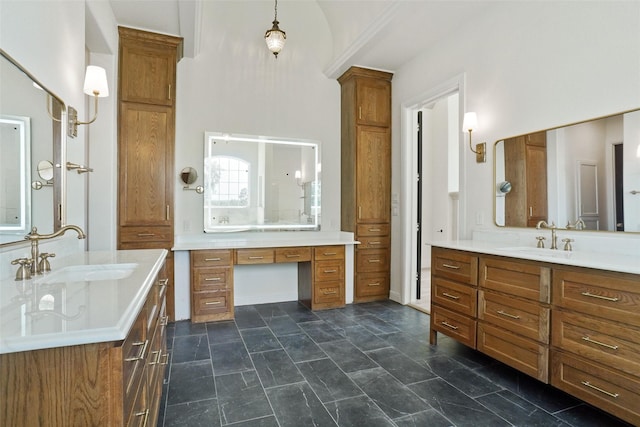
<box><xmin>172</xmin><ymin>231</ymin><xmax>359</xmax><ymax>251</ymax></box>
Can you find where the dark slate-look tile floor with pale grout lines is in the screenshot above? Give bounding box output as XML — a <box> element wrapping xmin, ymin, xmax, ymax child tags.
<box><xmin>158</xmin><ymin>301</ymin><xmax>627</xmax><ymax>427</ymax></box>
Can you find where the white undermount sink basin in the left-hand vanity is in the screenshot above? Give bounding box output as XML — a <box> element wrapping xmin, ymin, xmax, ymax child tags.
<box><xmin>34</xmin><ymin>263</ymin><xmax>138</xmax><ymax>285</ymax></box>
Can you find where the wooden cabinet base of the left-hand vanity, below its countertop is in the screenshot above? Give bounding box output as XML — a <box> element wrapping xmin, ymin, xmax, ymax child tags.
<box><xmin>0</xmin><ymin>267</ymin><xmax>169</xmax><ymax>426</ymax></box>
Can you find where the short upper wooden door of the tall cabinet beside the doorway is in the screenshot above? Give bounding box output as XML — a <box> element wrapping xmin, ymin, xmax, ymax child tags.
<box><xmin>356</xmin><ymin>79</ymin><xmax>391</xmax><ymax>126</ymax></box>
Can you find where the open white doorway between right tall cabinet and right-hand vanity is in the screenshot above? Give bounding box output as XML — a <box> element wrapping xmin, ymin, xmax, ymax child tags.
<box><xmin>410</xmin><ymin>91</ymin><xmax>460</xmax><ymax>313</ymax></box>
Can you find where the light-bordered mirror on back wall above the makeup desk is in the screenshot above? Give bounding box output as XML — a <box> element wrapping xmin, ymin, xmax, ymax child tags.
<box><xmin>204</xmin><ymin>132</ymin><xmax>321</xmax><ymax>233</ymax></box>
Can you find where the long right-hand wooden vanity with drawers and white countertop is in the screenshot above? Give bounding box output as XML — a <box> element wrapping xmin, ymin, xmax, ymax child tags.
<box><xmin>430</xmin><ymin>240</ymin><xmax>640</xmax><ymax>425</ymax></box>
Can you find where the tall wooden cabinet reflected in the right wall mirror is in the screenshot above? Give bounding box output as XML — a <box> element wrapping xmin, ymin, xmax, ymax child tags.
<box><xmin>504</xmin><ymin>131</ymin><xmax>547</xmax><ymax>227</ymax></box>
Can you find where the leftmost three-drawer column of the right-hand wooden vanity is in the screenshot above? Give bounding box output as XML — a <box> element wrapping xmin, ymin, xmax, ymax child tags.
<box><xmin>429</xmin><ymin>247</ymin><xmax>478</xmax><ymax>348</ymax></box>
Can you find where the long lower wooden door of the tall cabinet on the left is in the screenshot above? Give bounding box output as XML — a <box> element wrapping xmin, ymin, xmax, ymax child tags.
<box><xmin>119</xmin><ymin>102</ymin><xmax>174</xmax><ymax>226</ymax></box>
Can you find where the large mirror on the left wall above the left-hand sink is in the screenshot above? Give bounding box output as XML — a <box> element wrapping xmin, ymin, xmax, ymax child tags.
<box><xmin>0</xmin><ymin>49</ymin><xmax>65</xmax><ymax>244</ymax></box>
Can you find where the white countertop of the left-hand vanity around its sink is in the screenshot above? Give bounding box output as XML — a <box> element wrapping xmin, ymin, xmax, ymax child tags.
<box><xmin>0</xmin><ymin>249</ymin><xmax>167</xmax><ymax>354</ymax></box>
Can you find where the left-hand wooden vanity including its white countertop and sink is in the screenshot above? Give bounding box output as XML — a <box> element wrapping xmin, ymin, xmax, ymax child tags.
<box><xmin>0</xmin><ymin>249</ymin><xmax>168</xmax><ymax>426</ymax></box>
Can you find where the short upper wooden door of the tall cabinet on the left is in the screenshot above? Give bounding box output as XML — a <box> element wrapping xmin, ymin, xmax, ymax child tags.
<box><xmin>120</xmin><ymin>42</ymin><xmax>176</xmax><ymax>105</ymax></box>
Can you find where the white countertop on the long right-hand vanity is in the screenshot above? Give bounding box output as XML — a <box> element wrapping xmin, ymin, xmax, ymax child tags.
<box><xmin>429</xmin><ymin>240</ymin><xmax>640</xmax><ymax>274</ymax></box>
